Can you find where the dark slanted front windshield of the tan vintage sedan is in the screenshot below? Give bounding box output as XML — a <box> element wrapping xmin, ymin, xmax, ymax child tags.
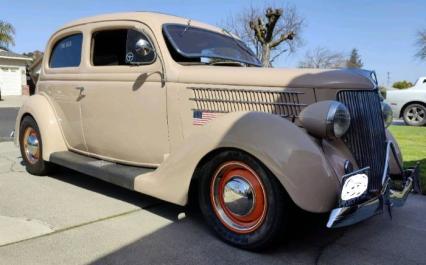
<box><xmin>163</xmin><ymin>24</ymin><xmax>261</xmax><ymax>66</ymax></box>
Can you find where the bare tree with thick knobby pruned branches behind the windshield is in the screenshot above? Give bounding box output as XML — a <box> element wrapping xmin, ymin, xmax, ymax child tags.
<box><xmin>223</xmin><ymin>2</ymin><xmax>304</xmax><ymax>67</ymax></box>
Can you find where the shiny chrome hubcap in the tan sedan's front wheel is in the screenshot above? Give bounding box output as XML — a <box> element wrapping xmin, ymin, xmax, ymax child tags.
<box><xmin>223</xmin><ymin>176</ymin><xmax>254</xmax><ymax>216</ymax></box>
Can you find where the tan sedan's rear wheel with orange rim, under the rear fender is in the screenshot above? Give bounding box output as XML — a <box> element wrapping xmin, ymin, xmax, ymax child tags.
<box><xmin>19</xmin><ymin>116</ymin><xmax>51</xmax><ymax>176</ymax></box>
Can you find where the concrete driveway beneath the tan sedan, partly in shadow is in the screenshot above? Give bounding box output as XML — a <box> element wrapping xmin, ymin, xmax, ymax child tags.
<box><xmin>0</xmin><ymin>142</ymin><xmax>426</xmax><ymax>265</ymax></box>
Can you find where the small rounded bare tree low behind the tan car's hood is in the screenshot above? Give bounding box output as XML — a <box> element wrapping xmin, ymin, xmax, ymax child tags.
<box><xmin>299</xmin><ymin>47</ymin><xmax>346</xmax><ymax>68</ymax></box>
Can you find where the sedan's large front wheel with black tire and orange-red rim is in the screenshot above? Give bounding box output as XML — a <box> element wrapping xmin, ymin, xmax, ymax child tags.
<box><xmin>198</xmin><ymin>150</ymin><xmax>290</xmax><ymax>250</ymax></box>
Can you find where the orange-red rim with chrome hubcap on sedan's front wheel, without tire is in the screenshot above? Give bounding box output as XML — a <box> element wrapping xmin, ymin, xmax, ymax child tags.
<box><xmin>210</xmin><ymin>161</ymin><xmax>267</xmax><ymax>234</ymax></box>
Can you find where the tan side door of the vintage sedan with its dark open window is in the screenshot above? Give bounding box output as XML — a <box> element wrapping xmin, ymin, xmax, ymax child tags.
<box><xmin>82</xmin><ymin>21</ymin><xmax>169</xmax><ymax>166</ymax></box>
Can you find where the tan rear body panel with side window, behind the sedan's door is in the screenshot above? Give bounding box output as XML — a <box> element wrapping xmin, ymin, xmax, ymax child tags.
<box><xmin>37</xmin><ymin>30</ymin><xmax>87</xmax><ymax>151</ymax></box>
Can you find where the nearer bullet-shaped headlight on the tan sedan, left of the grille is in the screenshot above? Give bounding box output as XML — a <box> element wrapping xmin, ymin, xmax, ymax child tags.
<box><xmin>300</xmin><ymin>100</ymin><xmax>351</xmax><ymax>139</ymax></box>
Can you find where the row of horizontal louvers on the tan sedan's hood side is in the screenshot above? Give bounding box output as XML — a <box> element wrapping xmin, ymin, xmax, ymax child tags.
<box><xmin>188</xmin><ymin>87</ymin><xmax>306</xmax><ymax>118</ymax></box>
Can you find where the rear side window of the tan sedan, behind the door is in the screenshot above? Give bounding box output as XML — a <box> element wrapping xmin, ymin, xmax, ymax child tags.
<box><xmin>49</xmin><ymin>33</ymin><xmax>83</xmax><ymax>68</ymax></box>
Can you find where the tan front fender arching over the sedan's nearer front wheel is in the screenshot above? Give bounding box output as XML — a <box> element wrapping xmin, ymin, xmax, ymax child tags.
<box><xmin>135</xmin><ymin>112</ymin><xmax>340</xmax><ymax>212</ymax></box>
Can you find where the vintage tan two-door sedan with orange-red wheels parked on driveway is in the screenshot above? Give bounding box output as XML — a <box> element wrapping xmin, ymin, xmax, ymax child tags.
<box><xmin>16</xmin><ymin>12</ymin><xmax>418</xmax><ymax>249</ymax></box>
